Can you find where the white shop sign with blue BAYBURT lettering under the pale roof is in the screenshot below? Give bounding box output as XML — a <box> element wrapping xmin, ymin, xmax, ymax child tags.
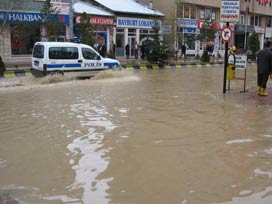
<box><xmin>116</xmin><ymin>17</ymin><xmax>161</xmax><ymax>29</ymax></box>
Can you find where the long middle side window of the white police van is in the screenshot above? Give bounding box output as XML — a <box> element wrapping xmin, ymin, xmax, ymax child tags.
<box><xmin>49</xmin><ymin>47</ymin><xmax>78</xmax><ymax>60</ymax></box>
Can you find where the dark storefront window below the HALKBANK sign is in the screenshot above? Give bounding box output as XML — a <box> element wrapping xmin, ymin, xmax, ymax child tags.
<box><xmin>10</xmin><ymin>24</ymin><xmax>40</xmax><ymax>55</ymax></box>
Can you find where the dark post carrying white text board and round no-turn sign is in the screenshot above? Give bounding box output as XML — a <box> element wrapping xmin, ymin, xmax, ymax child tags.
<box><xmin>220</xmin><ymin>0</ymin><xmax>240</xmax><ymax>94</ymax></box>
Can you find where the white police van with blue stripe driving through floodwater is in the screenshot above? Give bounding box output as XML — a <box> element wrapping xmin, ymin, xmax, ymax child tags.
<box><xmin>31</xmin><ymin>42</ymin><xmax>120</xmax><ymax>77</ymax></box>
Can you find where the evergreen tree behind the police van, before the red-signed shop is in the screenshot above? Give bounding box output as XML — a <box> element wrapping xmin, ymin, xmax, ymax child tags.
<box><xmin>75</xmin><ymin>12</ymin><xmax>94</xmax><ymax>46</ymax></box>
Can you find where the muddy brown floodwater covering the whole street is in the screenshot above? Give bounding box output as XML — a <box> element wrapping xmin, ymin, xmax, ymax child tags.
<box><xmin>0</xmin><ymin>65</ymin><xmax>272</xmax><ymax>204</ymax></box>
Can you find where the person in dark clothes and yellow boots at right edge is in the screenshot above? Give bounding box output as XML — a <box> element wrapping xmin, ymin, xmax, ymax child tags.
<box><xmin>257</xmin><ymin>41</ymin><xmax>272</xmax><ymax>96</ymax></box>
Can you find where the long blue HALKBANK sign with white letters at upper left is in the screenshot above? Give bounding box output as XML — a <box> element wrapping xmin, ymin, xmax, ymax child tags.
<box><xmin>0</xmin><ymin>11</ymin><xmax>70</xmax><ymax>25</ymax></box>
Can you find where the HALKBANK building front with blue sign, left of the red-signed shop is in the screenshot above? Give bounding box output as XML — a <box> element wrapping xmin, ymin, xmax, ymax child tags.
<box><xmin>0</xmin><ymin>0</ymin><xmax>70</xmax><ymax>62</ymax></box>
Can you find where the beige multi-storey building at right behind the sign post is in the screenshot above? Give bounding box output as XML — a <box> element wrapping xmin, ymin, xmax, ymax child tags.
<box><xmin>140</xmin><ymin>0</ymin><xmax>272</xmax><ymax>54</ymax></box>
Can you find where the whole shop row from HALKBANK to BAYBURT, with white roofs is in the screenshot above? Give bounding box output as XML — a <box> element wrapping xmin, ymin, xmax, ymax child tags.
<box><xmin>0</xmin><ymin>0</ymin><xmax>164</xmax><ymax>63</ymax></box>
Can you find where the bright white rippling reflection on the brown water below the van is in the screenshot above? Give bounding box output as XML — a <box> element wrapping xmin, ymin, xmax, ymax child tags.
<box><xmin>67</xmin><ymin>100</ymin><xmax>116</xmax><ymax>204</ymax></box>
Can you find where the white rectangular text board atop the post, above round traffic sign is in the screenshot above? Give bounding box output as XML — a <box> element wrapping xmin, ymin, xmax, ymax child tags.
<box><xmin>220</xmin><ymin>0</ymin><xmax>240</xmax><ymax>23</ymax></box>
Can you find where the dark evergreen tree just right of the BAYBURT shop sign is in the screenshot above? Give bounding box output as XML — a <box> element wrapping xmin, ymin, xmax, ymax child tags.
<box><xmin>145</xmin><ymin>21</ymin><xmax>170</xmax><ymax>63</ymax></box>
